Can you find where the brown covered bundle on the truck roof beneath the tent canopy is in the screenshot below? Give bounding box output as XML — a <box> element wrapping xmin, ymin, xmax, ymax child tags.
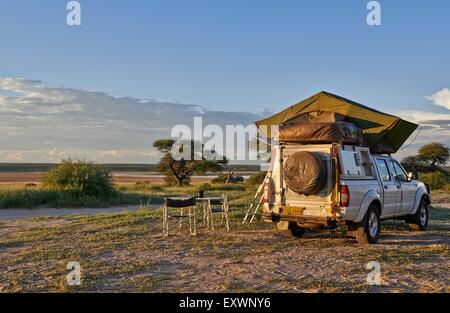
<box><xmin>279</xmin><ymin>122</ymin><xmax>363</xmax><ymax>144</ymax></box>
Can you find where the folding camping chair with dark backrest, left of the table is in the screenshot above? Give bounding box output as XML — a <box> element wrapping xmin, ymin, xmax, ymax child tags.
<box><xmin>163</xmin><ymin>196</ymin><xmax>197</xmax><ymax>237</ymax></box>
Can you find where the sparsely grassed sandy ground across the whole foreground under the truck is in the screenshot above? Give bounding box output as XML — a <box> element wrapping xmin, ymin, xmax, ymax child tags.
<box><xmin>0</xmin><ymin>203</ymin><xmax>450</xmax><ymax>292</ymax></box>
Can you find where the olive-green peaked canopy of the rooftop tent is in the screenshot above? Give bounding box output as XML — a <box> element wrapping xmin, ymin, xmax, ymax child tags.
<box><xmin>256</xmin><ymin>91</ymin><xmax>418</xmax><ymax>153</ymax></box>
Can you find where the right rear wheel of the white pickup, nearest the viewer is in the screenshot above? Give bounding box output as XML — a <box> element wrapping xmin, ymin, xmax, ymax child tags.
<box><xmin>352</xmin><ymin>204</ymin><xmax>381</xmax><ymax>244</ymax></box>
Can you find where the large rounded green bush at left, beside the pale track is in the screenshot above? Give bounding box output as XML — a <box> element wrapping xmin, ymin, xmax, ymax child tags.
<box><xmin>43</xmin><ymin>160</ymin><xmax>114</xmax><ymax>198</ymax></box>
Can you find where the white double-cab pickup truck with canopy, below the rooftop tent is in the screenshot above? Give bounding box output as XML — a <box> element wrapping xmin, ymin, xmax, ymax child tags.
<box><xmin>263</xmin><ymin>143</ymin><xmax>430</xmax><ymax>244</ymax></box>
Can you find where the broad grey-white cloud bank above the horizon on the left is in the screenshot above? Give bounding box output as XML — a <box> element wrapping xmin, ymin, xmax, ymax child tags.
<box><xmin>0</xmin><ymin>77</ymin><xmax>262</xmax><ymax>163</ymax></box>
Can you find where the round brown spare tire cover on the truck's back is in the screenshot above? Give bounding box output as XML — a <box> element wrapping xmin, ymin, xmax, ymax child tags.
<box><xmin>283</xmin><ymin>151</ymin><xmax>327</xmax><ymax>196</ymax></box>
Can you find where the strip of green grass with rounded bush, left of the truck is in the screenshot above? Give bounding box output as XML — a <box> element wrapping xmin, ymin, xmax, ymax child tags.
<box><xmin>0</xmin><ymin>156</ymin><xmax>255</xmax><ymax>209</ymax></box>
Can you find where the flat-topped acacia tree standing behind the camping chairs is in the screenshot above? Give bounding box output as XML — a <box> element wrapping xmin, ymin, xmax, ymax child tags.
<box><xmin>153</xmin><ymin>139</ymin><xmax>227</xmax><ymax>186</ymax></box>
